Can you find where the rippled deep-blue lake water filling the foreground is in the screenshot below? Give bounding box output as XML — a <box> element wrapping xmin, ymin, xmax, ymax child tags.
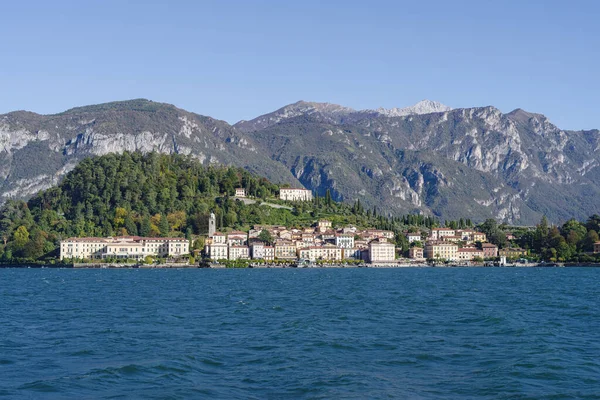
<box><xmin>0</xmin><ymin>268</ymin><xmax>600</xmax><ymax>399</ymax></box>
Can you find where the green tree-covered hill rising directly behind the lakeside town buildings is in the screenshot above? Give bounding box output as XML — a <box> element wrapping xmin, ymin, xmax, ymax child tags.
<box><xmin>0</xmin><ymin>152</ymin><xmax>435</xmax><ymax>261</ymax></box>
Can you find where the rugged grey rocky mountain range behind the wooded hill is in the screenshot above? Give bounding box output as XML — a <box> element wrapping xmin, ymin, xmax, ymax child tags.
<box><xmin>0</xmin><ymin>99</ymin><xmax>600</xmax><ymax>224</ymax></box>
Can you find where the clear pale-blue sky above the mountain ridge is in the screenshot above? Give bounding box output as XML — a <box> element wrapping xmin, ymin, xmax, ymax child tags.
<box><xmin>0</xmin><ymin>0</ymin><xmax>600</xmax><ymax>129</ymax></box>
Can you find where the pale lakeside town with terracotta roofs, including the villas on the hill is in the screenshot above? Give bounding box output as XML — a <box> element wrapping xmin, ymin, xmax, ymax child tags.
<box><xmin>60</xmin><ymin>188</ymin><xmax>526</xmax><ymax>265</ymax></box>
